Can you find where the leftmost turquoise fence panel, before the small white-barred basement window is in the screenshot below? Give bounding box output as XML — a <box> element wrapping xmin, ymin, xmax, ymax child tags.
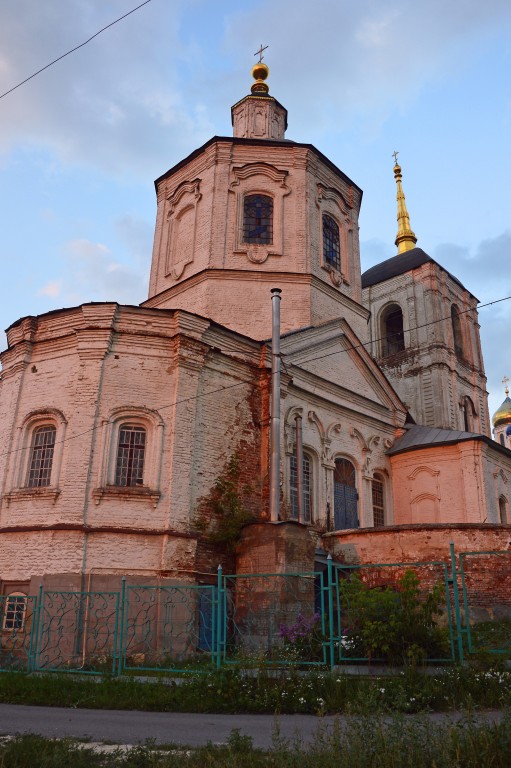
<box><xmin>0</xmin><ymin>595</ymin><xmax>37</xmax><ymax>672</ymax></box>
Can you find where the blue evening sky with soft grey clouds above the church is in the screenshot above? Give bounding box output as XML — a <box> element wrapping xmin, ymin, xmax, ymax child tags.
<box><xmin>0</xmin><ymin>0</ymin><xmax>511</xmax><ymax>420</ymax></box>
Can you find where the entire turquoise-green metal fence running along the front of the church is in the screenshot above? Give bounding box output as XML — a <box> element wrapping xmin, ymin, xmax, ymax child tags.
<box><xmin>0</xmin><ymin>544</ymin><xmax>511</xmax><ymax>675</ymax></box>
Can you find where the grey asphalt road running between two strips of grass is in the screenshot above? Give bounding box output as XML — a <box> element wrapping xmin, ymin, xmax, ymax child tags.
<box><xmin>0</xmin><ymin>704</ymin><xmax>502</xmax><ymax>747</ymax></box>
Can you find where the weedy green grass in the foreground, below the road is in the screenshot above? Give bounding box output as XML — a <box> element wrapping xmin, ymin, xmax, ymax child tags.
<box><xmin>0</xmin><ymin>717</ymin><xmax>511</xmax><ymax>768</ymax></box>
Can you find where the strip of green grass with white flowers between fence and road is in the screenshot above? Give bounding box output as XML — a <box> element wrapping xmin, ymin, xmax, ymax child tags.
<box><xmin>0</xmin><ymin>667</ymin><xmax>511</xmax><ymax>714</ymax></box>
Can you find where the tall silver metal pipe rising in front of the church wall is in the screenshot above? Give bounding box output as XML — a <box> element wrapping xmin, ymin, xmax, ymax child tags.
<box><xmin>270</xmin><ymin>288</ymin><xmax>282</xmax><ymax>523</ymax></box>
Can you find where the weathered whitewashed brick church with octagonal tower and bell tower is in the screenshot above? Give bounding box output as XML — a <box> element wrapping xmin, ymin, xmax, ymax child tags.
<box><xmin>0</xmin><ymin>63</ymin><xmax>511</xmax><ymax>594</ymax></box>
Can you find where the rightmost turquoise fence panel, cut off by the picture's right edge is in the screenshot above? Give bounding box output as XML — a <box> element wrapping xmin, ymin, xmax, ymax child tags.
<box><xmin>459</xmin><ymin>551</ymin><xmax>511</xmax><ymax>654</ymax></box>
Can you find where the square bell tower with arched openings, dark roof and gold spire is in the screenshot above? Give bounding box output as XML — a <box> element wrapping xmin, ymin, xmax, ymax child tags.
<box><xmin>362</xmin><ymin>158</ymin><xmax>490</xmax><ymax>437</ymax></box>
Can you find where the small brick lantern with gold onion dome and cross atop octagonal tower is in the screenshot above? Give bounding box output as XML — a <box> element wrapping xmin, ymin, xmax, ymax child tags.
<box><xmin>231</xmin><ymin>45</ymin><xmax>287</xmax><ymax>141</ymax></box>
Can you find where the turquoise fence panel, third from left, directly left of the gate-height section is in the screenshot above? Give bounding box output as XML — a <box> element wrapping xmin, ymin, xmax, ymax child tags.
<box><xmin>122</xmin><ymin>584</ymin><xmax>218</xmax><ymax>672</ymax></box>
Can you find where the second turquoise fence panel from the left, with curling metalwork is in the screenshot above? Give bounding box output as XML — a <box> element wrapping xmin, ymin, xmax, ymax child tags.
<box><xmin>34</xmin><ymin>592</ymin><xmax>119</xmax><ymax>674</ymax></box>
